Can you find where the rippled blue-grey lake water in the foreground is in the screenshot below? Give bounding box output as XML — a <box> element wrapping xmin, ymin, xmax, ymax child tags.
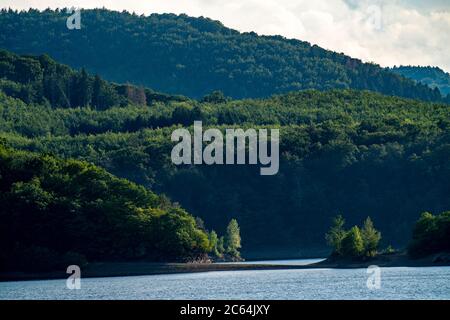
<box><xmin>0</xmin><ymin>260</ymin><xmax>450</xmax><ymax>300</ymax></box>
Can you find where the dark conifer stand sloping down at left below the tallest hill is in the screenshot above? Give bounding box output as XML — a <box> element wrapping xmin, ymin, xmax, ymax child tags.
<box><xmin>0</xmin><ymin>50</ymin><xmax>187</xmax><ymax>110</ymax></box>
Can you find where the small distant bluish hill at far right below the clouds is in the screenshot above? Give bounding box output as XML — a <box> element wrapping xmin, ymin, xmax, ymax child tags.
<box><xmin>391</xmin><ymin>66</ymin><xmax>450</xmax><ymax>96</ymax></box>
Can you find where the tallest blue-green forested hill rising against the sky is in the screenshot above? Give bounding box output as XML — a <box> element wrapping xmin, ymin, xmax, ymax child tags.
<box><xmin>0</xmin><ymin>9</ymin><xmax>442</xmax><ymax>101</ymax></box>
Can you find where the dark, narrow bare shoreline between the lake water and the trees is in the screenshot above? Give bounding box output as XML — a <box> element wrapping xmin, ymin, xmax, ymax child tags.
<box><xmin>0</xmin><ymin>254</ymin><xmax>450</xmax><ymax>282</ymax></box>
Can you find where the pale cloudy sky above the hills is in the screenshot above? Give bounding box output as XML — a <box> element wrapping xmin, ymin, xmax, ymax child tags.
<box><xmin>0</xmin><ymin>0</ymin><xmax>450</xmax><ymax>72</ymax></box>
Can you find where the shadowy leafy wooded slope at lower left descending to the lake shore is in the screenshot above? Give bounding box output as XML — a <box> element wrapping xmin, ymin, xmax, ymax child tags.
<box><xmin>0</xmin><ymin>141</ymin><xmax>240</xmax><ymax>272</ymax></box>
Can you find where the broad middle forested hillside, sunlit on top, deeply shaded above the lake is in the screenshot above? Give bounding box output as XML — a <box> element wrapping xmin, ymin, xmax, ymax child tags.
<box><xmin>0</xmin><ymin>53</ymin><xmax>450</xmax><ymax>257</ymax></box>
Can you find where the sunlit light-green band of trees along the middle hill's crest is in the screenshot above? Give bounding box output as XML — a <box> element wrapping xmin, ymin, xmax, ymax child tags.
<box><xmin>0</xmin><ymin>90</ymin><xmax>450</xmax><ymax>138</ymax></box>
